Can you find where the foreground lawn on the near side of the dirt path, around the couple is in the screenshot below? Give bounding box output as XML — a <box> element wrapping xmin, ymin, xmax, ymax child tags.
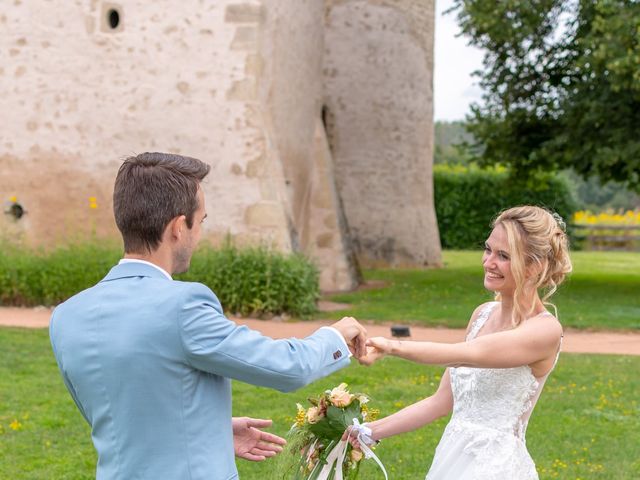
<box><xmin>0</xmin><ymin>328</ymin><xmax>640</xmax><ymax>480</ymax></box>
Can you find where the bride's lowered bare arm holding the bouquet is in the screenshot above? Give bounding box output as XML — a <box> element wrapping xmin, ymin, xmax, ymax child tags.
<box><xmin>367</xmin><ymin>369</ymin><xmax>453</xmax><ymax>440</ymax></box>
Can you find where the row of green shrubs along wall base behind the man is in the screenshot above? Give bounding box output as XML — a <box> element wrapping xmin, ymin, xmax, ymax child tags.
<box><xmin>0</xmin><ymin>242</ymin><xmax>319</xmax><ymax>317</ymax></box>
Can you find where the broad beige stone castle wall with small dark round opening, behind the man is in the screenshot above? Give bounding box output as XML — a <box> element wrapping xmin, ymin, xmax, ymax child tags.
<box><xmin>0</xmin><ymin>0</ymin><xmax>437</xmax><ymax>289</ymax></box>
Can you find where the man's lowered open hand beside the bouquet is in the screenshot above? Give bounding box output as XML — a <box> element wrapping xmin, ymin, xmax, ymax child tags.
<box><xmin>231</xmin><ymin>417</ymin><xmax>287</xmax><ymax>462</ymax></box>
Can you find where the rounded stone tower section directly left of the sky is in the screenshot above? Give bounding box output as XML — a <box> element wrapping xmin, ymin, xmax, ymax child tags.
<box><xmin>324</xmin><ymin>0</ymin><xmax>440</xmax><ymax>266</ymax></box>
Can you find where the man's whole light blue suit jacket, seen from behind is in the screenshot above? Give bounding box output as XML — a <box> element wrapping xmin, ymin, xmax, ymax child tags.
<box><xmin>50</xmin><ymin>263</ymin><xmax>349</xmax><ymax>480</ymax></box>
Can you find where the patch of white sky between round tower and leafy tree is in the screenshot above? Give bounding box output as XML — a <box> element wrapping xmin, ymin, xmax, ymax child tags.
<box><xmin>433</xmin><ymin>0</ymin><xmax>483</xmax><ymax>121</ymax></box>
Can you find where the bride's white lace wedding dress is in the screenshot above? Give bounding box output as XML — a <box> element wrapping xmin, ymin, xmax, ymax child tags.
<box><xmin>426</xmin><ymin>302</ymin><xmax>559</xmax><ymax>480</ymax></box>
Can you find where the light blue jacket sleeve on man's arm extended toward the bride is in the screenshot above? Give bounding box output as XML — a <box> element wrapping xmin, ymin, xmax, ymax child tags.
<box><xmin>178</xmin><ymin>283</ymin><xmax>349</xmax><ymax>391</ymax></box>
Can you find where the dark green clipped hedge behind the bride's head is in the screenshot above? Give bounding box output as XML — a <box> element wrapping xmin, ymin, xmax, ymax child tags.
<box><xmin>434</xmin><ymin>165</ymin><xmax>576</xmax><ymax>249</ymax></box>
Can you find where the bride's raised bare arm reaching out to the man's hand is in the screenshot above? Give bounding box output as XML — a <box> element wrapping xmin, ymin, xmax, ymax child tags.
<box><xmin>361</xmin><ymin>315</ymin><xmax>562</xmax><ymax>368</ymax></box>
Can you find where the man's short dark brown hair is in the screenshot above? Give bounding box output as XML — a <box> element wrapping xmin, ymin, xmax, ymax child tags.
<box><xmin>113</xmin><ymin>153</ymin><xmax>211</xmax><ymax>253</ymax></box>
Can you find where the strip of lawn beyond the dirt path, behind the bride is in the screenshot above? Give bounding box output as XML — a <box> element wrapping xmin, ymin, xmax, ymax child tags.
<box><xmin>318</xmin><ymin>250</ymin><xmax>640</xmax><ymax>330</ymax></box>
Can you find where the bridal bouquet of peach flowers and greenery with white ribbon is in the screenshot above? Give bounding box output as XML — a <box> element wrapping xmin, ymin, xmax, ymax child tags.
<box><xmin>278</xmin><ymin>383</ymin><xmax>386</xmax><ymax>480</ymax></box>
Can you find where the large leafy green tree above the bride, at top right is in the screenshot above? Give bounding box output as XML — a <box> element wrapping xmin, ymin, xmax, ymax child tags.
<box><xmin>451</xmin><ymin>0</ymin><xmax>640</xmax><ymax>190</ymax></box>
